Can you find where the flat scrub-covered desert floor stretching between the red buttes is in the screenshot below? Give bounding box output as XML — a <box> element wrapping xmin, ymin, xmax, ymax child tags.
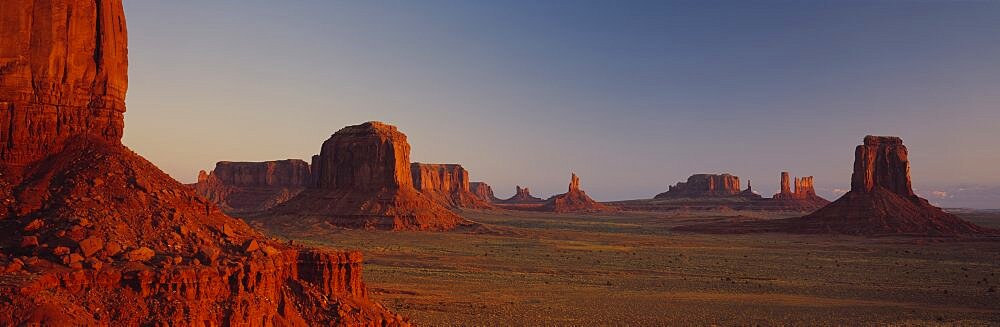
<box><xmin>252</xmin><ymin>210</ymin><xmax>1000</xmax><ymax>326</ymax></box>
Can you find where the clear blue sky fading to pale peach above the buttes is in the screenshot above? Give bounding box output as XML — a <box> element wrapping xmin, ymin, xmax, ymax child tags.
<box><xmin>125</xmin><ymin>0</ymin><xmax>1000</xmax><ymax>206</ymax></box>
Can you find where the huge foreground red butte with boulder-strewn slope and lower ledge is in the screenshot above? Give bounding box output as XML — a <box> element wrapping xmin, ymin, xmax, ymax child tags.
<box><xmin>0</xmin><ymin>0</ymin><xmax>405</xmax><ymax>326</ymax></box>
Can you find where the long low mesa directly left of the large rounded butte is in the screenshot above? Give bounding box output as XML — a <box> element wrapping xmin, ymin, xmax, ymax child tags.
<box><xmin>192</xmin><ymin>159</ymin><xmax>312</xmax><ymax>214</ymax></box>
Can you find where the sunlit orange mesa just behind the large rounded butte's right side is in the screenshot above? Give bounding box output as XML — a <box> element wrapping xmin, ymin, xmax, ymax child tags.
<box><xmin>410</xmin><ymin>163</ymin><xmax>493</xmax><ymax>209</ymax></box>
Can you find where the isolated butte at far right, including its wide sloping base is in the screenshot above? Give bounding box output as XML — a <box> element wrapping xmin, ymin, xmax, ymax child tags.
<box><xmin>782</xmin><ymin>135</ymin><xmax>994</xmax><ymax>236</ymax></box>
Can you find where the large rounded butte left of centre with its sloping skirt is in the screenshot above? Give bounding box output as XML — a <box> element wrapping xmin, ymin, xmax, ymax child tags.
<box><xmin>265</xmin><ymin>122</ymin><xmax>468</xmax><ymax>230</ymax></box>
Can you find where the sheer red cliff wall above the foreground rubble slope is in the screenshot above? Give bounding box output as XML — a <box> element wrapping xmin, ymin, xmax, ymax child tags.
<box><xmin>0</xmin><ymin>0</ymin><xmax>128</xmax><ymax>172</ymax></box>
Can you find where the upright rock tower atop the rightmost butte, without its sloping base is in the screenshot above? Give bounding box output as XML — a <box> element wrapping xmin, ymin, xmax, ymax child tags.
<box><xmin>851</xmin><ymin>135</ymin><xmax>914</xmax><ymax>197</ymax></box>
